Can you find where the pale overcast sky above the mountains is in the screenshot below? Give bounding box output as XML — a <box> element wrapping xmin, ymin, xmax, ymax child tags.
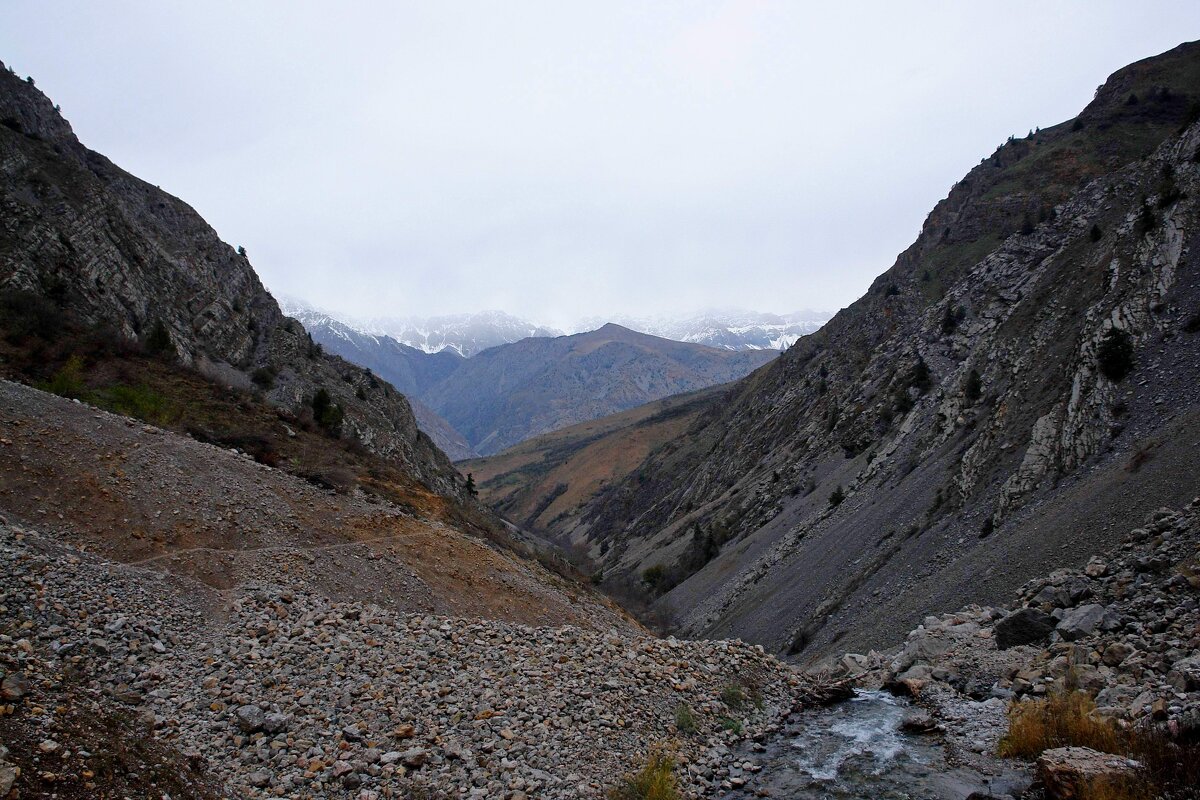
<box><xmin>0</xmin><ymin>0</ymin><xmax>1200</xmax><ymax>326</ymax></box>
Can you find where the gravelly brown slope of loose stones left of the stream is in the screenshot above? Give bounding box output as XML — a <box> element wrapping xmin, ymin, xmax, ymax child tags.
<box><xmin>0</xmin><ymin>383</ymin><xmax>825</xmax><ymax>799</ymax></box>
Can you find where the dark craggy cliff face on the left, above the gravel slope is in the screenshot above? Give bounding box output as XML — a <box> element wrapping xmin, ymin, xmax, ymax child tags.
<box><xmin>0</xmin><ymin>68</ymin><xmax>462</xmax><ymax>494</ymax></box>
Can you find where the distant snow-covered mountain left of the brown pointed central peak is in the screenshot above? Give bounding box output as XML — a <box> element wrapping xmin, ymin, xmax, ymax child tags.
<box><xmin>362</xmin><ymin>311</ymin><xmax>563</xmax><ymax>357</ymax></box>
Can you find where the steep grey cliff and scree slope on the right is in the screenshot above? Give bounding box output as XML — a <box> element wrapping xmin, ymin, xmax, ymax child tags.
<box><xmin>554</xmin><ymin>44</ymin><xmax>1200</xmax><ymax>656</ymax></box>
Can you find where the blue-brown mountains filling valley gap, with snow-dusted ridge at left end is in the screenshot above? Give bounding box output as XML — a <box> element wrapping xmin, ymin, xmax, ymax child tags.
<box><xmin>289</xmin><ymin>305</ymin><xmax>775</xmax><ymax>459</ymax></box>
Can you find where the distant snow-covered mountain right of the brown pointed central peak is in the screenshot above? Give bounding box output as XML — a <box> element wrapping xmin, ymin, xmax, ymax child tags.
<box><xmin>581</xmin><ymin>309</ymin><xmax>832</xmax><ymax>350</ymax></box>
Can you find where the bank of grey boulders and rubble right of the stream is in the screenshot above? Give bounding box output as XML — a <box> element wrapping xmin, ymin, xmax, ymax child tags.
<box><xmin>834</xmin><ymin>498</ymin><xmax>1200</xmax><ymax>746</ymax></box>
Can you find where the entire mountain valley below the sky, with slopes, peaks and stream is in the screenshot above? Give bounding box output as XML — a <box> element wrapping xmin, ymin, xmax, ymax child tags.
<box><xmin>0</xmin><ymin>32</ymin><xmax>1200</xmax><ymax>800</ymax></box>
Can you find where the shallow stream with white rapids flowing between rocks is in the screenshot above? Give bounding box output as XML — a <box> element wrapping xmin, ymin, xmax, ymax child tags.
<box><xmin>722</xmin><ymin>691</ymin><xmax>1028</xmax><ymax>800</ymax></box>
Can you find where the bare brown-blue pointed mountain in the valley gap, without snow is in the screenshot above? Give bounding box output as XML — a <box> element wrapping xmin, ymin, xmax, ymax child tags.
<box><xmin>421</xmin><ymin>324</ymin><xmax>775</xmax><ymax>455</ymax></box>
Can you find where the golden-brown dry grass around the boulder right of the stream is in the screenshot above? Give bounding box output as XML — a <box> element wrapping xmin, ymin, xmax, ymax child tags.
<box><xmin>1000</xmin><ymin>691</ymin><xmax>1200</xmax><ymax>800</ymax></box>
